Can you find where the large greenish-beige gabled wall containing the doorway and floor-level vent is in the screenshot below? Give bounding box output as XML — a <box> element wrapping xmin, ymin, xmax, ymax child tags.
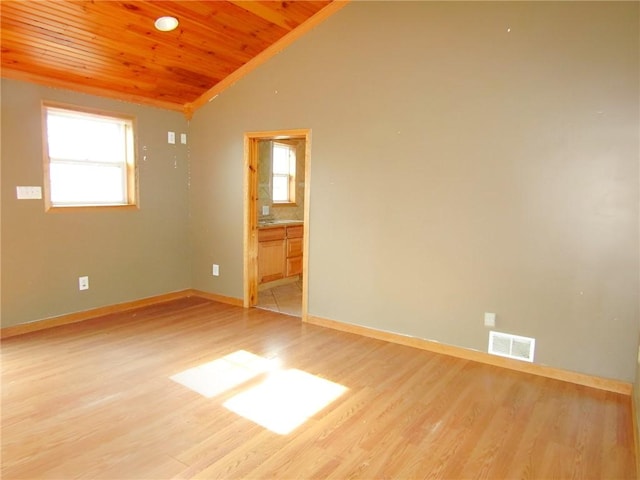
<box><xmin>190</xmin><ymin>2</ymin><xmax>640</xmax><ymax>381</ymax></box>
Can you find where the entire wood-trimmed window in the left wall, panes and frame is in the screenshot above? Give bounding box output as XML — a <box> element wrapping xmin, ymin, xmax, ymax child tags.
<box><xmin>43</xmin><ymin>104</ymin><xmax>137</xmax><ymax>209</ymax></box>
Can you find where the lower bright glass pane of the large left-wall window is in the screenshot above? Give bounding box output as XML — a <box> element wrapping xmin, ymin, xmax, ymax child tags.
<box><xmin>50</xmin><ymin>163</ymin><xmax>127</xmax><ymax>205</ymax></box>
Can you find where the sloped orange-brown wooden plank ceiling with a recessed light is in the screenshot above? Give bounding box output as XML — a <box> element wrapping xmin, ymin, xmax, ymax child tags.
<box><xmin>0</xmin><ymin>0</ymin><xmax>342</xmax><ymax>115</ymax></box>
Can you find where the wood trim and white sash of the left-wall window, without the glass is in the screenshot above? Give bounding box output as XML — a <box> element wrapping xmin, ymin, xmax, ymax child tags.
<box><xmin>42</xmin><ymin>102</ymin><xmax>138</xmax><ymax>211</ymax></box>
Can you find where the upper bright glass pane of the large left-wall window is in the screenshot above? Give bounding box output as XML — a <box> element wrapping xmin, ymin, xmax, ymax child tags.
<box><xmin>47</xmin><ymin>110</ymin><xmax>126</xmax><ymax>163</ymax></box>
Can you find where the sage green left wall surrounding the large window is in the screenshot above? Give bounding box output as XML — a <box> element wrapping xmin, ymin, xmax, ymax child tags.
<box><xmin>1</xmin><ymin>80</ymin><xmax>191</xmax><ymax>327</ymax></box>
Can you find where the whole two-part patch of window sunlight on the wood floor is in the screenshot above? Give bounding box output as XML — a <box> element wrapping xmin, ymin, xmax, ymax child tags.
<box><xmin>171</xmin><ymin>350</ymin><xmax>348</xmax><ymax>435</ymax></box>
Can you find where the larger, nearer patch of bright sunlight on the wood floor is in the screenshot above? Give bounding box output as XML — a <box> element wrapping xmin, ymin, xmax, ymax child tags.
<box><xmin>224</xmin><ymin>369</ymin><xmax>347</xmax><ymax>435</ymax></box>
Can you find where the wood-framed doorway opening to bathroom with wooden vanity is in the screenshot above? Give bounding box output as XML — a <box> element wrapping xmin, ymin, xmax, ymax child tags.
<box><xmin>244</xmin><ymin>129</ymin><xmax>311</xmax><ymax>321</ymax></box>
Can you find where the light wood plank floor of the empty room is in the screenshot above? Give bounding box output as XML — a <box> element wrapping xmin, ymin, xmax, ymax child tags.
<box><xmin>2</xmin><ymin>297</ymin><xmax>635</xmax><ymax>480</ymax></box>
